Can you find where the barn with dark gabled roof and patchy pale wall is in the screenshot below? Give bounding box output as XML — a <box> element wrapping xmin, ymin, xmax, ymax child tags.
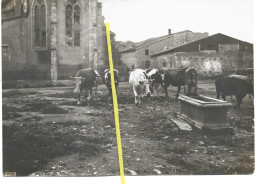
<box><xmin>150</xmin><ymin>33</ymin><xmax>253</xmax><ymax>76</ymax></box>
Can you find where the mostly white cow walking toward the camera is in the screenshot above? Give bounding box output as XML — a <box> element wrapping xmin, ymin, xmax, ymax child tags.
<box><xmin>129</xmin><ymin>69</ymin><xmax>152</xmax><ymax>106</ymax></box>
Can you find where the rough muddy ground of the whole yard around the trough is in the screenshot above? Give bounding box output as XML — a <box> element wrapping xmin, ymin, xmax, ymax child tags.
<box><xmin>2</xmin><ymin>81</ymin><xmax>254</xmax><ymax>176</ymax></box>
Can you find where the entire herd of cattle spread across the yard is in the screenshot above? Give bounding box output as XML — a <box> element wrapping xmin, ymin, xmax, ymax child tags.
<box><xmin>70</xmin><ymin>67</ymin><xmax>254</xmax><ymax>109</ymax></box>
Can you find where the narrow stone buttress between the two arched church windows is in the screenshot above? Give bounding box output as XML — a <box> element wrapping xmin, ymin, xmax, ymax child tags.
<box><xmin>50</xmin><ymin>0</ymin><xmax>58</xmax><ymax>82</ymax></box>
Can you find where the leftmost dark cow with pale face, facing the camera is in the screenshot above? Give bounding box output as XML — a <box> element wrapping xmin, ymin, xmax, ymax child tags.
<box><xmin>73</xmin><ymin>68</ymin><xmax>96</xmax><ymax>105</ymax></box>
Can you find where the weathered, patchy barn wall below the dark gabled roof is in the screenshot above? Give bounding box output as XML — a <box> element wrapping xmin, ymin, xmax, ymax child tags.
<box><xmin>152</xmin><ymin>51</ymin><xmax>253</xmax><ymax>76</ymax></box>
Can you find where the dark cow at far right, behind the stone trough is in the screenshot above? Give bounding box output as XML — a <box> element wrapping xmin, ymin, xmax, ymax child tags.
<box><xmin>215</xmin><ymin>74</ymin><xmax>254</xmax><ymax>110</ymax></box>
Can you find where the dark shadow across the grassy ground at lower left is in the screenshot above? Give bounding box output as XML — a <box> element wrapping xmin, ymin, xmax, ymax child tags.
<box><xmin>3</xmin><ymin>122</ymin><xmax>109</xmax><ymax>176</ymax></box>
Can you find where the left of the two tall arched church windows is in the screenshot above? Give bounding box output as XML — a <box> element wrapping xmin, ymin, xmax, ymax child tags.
<box><xmin>32</xmin><ymin>0</ymin><xmax>47</xmax><ymax>49</ymax></box>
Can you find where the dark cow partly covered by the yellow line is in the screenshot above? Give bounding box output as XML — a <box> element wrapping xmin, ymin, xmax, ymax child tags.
<box><xmin>102</xmin><ymin>69</ymin><xmax>119</xmax><ymax>101</ymax></box>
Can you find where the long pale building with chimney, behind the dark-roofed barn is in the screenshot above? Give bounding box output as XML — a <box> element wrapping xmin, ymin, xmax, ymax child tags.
<box><xmin>120</xmin><ymin>29</ymin><xmax>208</xmax><ymax>68</ymax></box>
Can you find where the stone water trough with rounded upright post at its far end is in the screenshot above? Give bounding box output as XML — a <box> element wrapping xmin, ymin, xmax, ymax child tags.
<box><xmin>178</xmin><ymin>69</ymin><xmax>232</xmax><ymax>130</ymax></box>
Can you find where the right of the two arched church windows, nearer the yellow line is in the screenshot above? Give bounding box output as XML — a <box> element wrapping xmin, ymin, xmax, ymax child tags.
<box><xmin>65</xmin><ymin>0</ymin><xmax>80</xmax><ymax>47</ymax></box>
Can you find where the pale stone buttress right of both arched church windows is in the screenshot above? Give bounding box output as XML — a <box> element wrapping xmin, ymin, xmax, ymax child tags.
<box><xmin>89</xmin><ymin>0</ymin><xmax>98</xmax><ymax>69</ymax></box>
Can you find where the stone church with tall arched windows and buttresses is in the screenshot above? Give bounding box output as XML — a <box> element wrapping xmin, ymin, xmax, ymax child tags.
<box><xmin>1</xmin><ymin>0</ymin><xmax>116</xmax><ymax>81</ymax></box>
